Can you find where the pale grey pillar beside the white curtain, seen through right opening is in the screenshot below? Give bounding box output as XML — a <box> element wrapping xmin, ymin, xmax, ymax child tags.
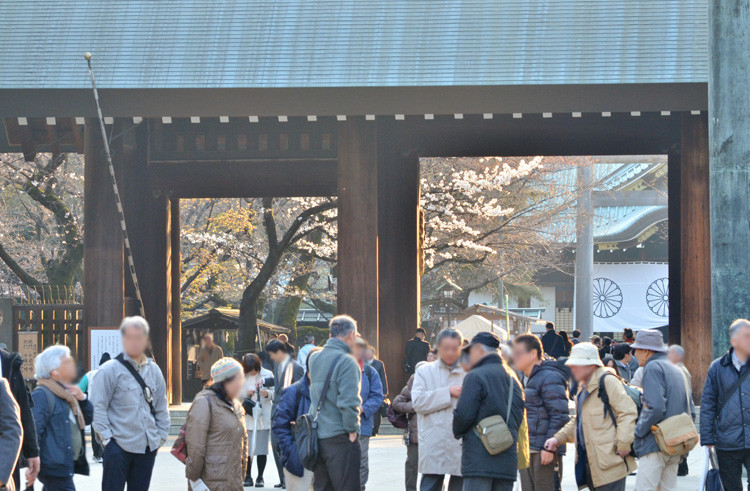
<box><xmin>575</xmin><ymin>163</ymin><xmax>594</xmax><ymax>341</ymax></box>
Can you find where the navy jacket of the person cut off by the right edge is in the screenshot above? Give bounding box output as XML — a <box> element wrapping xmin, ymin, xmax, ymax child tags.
<box><xmin>700</xmin><ymin>349</ymin><xmax>750</xmax><ymax>450</ymax></box>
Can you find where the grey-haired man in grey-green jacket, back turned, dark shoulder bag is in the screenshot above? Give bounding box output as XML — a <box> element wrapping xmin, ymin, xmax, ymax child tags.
<box><xmin>307</xmin><ymin>315</ymin><xmax>362</xmax><ymax>491</ymax></box>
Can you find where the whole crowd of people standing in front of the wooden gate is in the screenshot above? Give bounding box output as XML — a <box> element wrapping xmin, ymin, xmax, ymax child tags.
<box><xmin>0</xmin><ymin>315</ymin><xmax>750</xmax><ymax>491</ymax></box>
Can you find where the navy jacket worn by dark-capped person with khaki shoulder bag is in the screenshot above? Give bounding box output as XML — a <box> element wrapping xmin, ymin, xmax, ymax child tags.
<box><xmin>453</xmin><ymin>354</ymin><xmax>524</xmax><ymax>481</ymax></box>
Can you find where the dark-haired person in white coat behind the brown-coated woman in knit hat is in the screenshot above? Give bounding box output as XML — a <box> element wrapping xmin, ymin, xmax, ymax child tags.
<box><xmin>242</xmin><ymin>353</ymin><xmax>274</xmax><ymax>488</ymax></box>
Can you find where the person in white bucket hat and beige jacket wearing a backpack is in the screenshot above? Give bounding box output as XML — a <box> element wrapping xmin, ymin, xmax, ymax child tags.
<box><xmin>544</xmin><ymin>343</ymin><xmax>638</xmax><ymax>491</ymax></box>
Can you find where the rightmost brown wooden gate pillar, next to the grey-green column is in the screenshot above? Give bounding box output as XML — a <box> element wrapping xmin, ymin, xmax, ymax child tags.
<box><xmin>684</xmin><ymin>113</ymin><xmax>712</xmax><ymax>401</ymax></box>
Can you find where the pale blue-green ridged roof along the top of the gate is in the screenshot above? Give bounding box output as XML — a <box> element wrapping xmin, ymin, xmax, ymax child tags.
<box><xmin>0</xmin><ymin>0</ymin><xmax>708</xmax><ymax>88</ymax></box>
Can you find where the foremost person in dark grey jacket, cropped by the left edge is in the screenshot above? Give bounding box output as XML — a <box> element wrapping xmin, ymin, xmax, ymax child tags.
<box><xmin>0</xmin><ymin>377</ymin><xmax>23</xmax><ymax>491</ymax></box>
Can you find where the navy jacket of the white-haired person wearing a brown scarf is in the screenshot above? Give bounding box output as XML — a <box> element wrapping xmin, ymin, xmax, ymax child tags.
<box><xmin>31</xmin><ymin>387</ymin><xmax>94</xmax><ymax>477</ymax></box>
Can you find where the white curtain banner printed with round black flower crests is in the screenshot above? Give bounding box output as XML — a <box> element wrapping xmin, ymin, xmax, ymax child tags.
<box><xmin>594</xmin><ymin>263</ymin><xmax>669</xmax><ymax>332</ymax></box>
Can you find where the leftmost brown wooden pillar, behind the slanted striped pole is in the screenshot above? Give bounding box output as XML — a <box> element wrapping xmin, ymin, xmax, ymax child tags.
<box><xmin>81</xmin><ymin>119</ymin><xmax>123</xmax><ymax>362</ymax></box>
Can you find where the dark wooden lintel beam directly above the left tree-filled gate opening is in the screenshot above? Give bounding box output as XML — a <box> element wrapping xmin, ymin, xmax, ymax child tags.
<box><xmin>150</xmin><ymin>159</ymin><xmax>337</xmax><ymax>198</ymax></box>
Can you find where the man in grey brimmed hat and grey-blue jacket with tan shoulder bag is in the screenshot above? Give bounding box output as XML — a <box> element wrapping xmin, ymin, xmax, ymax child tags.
<box><xmin>631</xmin><ymin>329</ymin><xmax>694</xmax><ymax>491</ymax></box>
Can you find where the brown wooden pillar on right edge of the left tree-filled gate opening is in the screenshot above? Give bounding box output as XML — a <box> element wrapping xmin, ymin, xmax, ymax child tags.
<box><xmin>337</xmin><ymin>118</ymin><xmax>378</xmax><ymax>347</ymax></box>
